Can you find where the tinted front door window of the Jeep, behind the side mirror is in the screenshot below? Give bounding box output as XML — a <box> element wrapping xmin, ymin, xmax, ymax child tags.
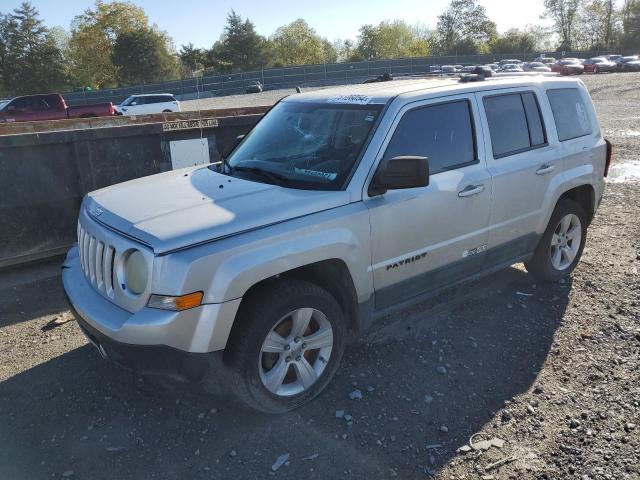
<box><xmin>384</xmin><ymin>100</ymin><xmax>476</xmax><ymax>174</ymax></box>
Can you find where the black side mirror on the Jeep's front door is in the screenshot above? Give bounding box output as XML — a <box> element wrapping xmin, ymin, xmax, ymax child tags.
<box><xmin>369</xmin><ymin>156</ymin><xmax>429</xmax><ymax>197</ymax></box>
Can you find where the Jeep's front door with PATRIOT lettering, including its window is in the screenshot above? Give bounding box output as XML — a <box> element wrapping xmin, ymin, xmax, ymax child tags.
<box><xmin>365</xmin><ymin>95</ymin><xmax>491</xmax><ymax>310</ymax></box>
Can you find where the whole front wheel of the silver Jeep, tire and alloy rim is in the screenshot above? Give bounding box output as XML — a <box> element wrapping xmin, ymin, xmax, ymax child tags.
<box><xmin>225</xmin><ymin>280</ymin><xmax>346</xmax><ymax>413</ymax></box>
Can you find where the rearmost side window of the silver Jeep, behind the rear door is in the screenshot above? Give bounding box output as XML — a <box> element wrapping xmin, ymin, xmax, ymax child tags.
<box><xmin>547</xmin><ymin>88</ymin><xmax>591</xmax><ymax>142</ymax></box>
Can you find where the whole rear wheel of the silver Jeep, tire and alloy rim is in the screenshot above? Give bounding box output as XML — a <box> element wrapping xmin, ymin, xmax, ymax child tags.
<box><xmin>524</xmin><ymin>199</ymin><xmax>587</xmax><ymax>282</ymax></box>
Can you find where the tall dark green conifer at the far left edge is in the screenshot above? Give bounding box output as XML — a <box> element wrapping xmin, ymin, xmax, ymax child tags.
<box><xmin>0</xmin><ymin>2</ymin><xmax>67</xmax><ymax>95</ymax></box>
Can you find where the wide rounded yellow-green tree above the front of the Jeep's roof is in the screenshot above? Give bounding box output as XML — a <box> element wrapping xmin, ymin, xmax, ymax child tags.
<box><xmin>357</xmin><ymin>20</ymin><xmax>429</xmax><ymax>60</ymax></box>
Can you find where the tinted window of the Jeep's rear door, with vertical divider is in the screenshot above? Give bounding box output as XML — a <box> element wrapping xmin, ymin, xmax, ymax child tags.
<box><xmin>483</xmin><ymin>92</ymin><xmax>547</xmax><ymax>158</ymax></box>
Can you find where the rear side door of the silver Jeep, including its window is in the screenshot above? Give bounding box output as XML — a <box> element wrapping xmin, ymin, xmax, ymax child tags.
<box><xmin>476</xmin><ymin>87</ymin><xmax>562</xmax><ymax>267</ymax></box>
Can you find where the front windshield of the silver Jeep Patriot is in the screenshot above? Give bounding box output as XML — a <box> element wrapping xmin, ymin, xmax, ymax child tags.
<box><xmin>222</xmin><ymin>101</ymin><xmax>382</xmax><ymax>190</ymax></box>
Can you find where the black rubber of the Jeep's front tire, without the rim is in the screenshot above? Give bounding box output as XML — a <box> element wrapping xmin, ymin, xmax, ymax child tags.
<box><xmin>225</xmin><ymin>280</ymin><xmax>346</xmax><ymax>413</ymax></box>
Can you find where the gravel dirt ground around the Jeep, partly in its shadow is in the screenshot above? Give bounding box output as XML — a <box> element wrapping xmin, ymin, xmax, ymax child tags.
<box><xmin>0</xmin><ymin>74</ymin><xmax>640</xmax><ymax>480</ymax></box>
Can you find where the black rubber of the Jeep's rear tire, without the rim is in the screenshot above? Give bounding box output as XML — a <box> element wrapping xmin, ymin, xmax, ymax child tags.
<box><xmin>524</xmin><ymin>199</ymin><xmax>587</xmax><ymax>282</ymax></box>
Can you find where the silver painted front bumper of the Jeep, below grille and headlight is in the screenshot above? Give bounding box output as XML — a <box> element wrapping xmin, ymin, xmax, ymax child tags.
<box><xmin>62</xmin><ymin>247</ymin><xmax>241</xmax><ymax>353</ymax></box>
